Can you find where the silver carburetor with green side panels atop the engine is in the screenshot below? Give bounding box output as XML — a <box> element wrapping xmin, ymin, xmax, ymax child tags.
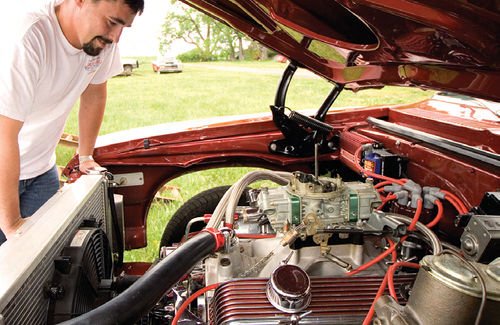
<box><xmin>257</xmin><ymin>172</ymin><xmax>382</xmax><ymax>235</ymax></box>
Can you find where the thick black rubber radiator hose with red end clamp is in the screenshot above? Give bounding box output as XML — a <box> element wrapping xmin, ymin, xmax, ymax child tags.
<box><xmin>60</xmin><ymin>232</ymin><xmax>217</xmax><ymax>325</ymax></box>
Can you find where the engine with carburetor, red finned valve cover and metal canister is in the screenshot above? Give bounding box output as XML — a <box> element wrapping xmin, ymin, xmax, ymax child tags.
<box><xmin>157</xmin><ymin>172</ymin><xmax>500</xmax><ymax>324</ymax></box>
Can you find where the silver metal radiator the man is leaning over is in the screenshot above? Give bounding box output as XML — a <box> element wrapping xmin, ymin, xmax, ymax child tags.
<box><xmin>0</xmin><ymin>175</ymin><xmax>110</xmax><ymax>325</ymax></box>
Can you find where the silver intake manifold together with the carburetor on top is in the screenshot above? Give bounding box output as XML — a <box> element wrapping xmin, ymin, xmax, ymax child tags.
<box><xmin>205</xmin><ymin>173</ymin><xmax>392</xmax><ymax>284</ymax></box>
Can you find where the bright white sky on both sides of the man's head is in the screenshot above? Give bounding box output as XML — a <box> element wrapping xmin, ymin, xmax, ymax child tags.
<box><xmin>0</xmin><ymin>0</ymin><xmax>191</xmax><ymax>57</ymax></box>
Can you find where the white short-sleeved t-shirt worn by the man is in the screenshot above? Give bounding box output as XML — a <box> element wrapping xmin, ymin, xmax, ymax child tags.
<box><xmin>0</xmin><ymin>0</ymin><xmax>122</xmax><ymax>179</ymax></box>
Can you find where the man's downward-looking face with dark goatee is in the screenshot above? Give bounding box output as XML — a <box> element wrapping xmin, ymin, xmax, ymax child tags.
<box><xmin>77</xmin><ymin>0</ymin><xmax>136</xmax><ymax>56</ymax></box>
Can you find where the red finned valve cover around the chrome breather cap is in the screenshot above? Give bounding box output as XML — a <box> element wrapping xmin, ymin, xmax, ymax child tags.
<box><xmin>210</xmin><ymin>275</ymin><xmax>415</xmax><ymax>325</ymax></box>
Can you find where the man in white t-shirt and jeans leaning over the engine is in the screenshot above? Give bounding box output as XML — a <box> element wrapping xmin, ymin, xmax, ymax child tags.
<box><xmin>0</xmin><ymin>0</ymin><xmax>144</xmax><ymax>244</ymax></box>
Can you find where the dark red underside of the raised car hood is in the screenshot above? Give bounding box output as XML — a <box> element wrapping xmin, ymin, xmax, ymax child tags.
<box><xmin>182</xmin><ymin>0</ymin><xmax>500</xmax><ymax>101</ymax></box>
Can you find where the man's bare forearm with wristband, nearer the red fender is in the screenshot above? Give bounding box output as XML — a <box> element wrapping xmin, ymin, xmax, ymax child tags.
<box><xmin>78</xmin><ymin>82</ymin><xmax>107</xmax><ymax>172</ymax></box>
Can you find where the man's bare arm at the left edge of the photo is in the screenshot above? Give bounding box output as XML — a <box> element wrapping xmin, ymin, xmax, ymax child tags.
<box><xmin>0</xmin><ymin>115</ymin><xmax>24</xmax><ymax>239</ymax></box>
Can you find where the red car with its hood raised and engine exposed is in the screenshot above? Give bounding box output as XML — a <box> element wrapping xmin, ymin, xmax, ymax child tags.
<box><xmin>0</xmin><ymin>0</ymin><xmax>500</xmax><ymax>325</ymax></box>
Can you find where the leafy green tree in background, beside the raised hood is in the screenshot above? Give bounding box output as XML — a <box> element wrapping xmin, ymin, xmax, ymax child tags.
<box><xmin>160</xmin><ymin>1</ymin><xmax>243</xmax><ymax>61</ymax></box>
